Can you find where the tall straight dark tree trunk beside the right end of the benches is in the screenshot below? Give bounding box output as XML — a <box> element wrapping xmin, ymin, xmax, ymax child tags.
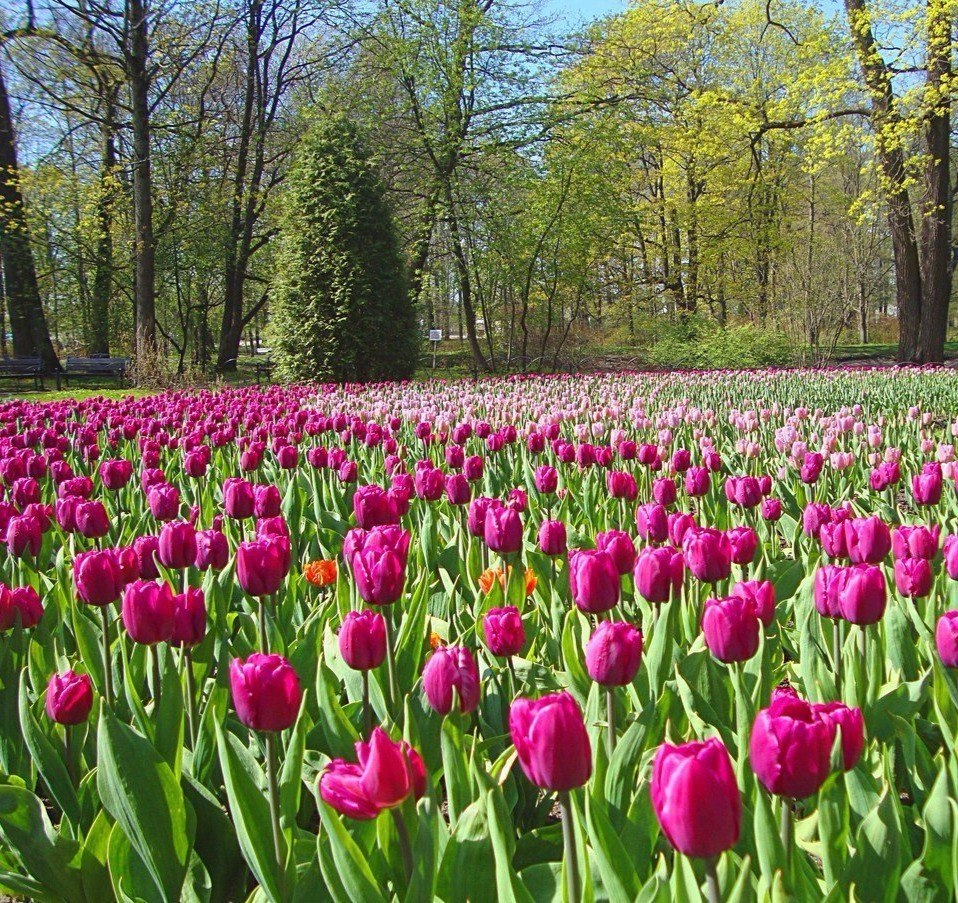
<box><xmin>125</xmin><ymin>0</ymin><xmax>156</xmax><ymax>358</ymax></box>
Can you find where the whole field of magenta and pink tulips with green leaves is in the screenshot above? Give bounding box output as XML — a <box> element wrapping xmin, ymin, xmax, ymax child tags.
<box><xmin>7</xmin><ymin>368</ymin><xmax>958</xmax><ymax>903</ymax></box>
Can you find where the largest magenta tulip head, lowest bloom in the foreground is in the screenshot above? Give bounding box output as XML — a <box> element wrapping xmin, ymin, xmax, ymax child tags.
<box><xmin>650</xmin><ymin>737</ymin><xmax>742</xmax><ymax>859</ymax></box>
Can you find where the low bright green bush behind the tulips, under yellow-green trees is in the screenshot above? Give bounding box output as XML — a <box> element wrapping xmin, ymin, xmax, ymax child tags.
<box><xmin>649</xmin><ymin>320</ymin><xmax>794</xmax><ymax>370</ymax></box>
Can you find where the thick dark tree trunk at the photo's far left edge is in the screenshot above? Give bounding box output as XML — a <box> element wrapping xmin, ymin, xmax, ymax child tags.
<box><xmin>0</xmin><ymin>61</ymin><xmax>60</xmax><ymax>372</ymax></box>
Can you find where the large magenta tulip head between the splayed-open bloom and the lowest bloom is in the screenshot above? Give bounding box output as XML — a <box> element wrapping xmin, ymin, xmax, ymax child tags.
<box><xmin>509</xmin><ymin>692</ymin><xmax>592</xmax><ymax>791</ymax></box>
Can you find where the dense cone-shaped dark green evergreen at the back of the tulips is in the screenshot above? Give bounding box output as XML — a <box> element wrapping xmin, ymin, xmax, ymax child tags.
<box><xmin>270</xmin><ymin>116</ymin><xmax>418</xmax><ymax>381</ymax></box>
